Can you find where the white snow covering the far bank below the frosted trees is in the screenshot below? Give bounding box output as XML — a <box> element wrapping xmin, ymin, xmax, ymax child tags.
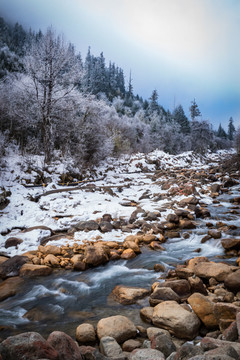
<box><xmin>0</xmin><ymin>150</ymin><xmax>235</xmax><ymax>256</ymax></box>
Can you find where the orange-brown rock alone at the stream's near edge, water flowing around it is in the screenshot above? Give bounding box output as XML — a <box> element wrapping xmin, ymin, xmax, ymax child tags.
<box><xmin>112</xmin><ymin>285</ymin><xmax>150</xmax><ymax>305</ymax></box>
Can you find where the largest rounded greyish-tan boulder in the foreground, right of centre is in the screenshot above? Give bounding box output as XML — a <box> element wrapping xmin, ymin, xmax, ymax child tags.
<box><xmin>152</xmin><ymin>301</ymin><xmax>200</xmax><ymax>340</ymax></box>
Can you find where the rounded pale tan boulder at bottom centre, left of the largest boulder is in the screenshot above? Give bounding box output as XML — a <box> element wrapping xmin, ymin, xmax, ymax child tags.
<box><xmin>97</xmin><ymin>315</ymin><xmax>137</xmax><ymax>343</ymax></box>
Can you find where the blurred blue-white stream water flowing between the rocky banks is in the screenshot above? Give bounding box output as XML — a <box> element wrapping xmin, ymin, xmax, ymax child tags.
<box><xmin>0</xmin><ymin>187</ymin><xmax>240</xmax><ymax>337</ymax></box>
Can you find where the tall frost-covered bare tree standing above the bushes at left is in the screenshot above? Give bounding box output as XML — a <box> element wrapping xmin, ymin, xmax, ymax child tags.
<box><xmin>24</xmin><ymin>28</ymin><xmax>81</xmax><ymax>163</ymax></box>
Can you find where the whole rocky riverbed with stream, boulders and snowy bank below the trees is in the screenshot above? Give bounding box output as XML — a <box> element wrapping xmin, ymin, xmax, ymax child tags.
<box><xmin>0</xmin><ymin>149</ymin><xmax>240</xmax><ymax>360</ymax></box>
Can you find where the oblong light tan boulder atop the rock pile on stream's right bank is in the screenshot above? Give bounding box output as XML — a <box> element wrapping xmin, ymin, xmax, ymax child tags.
<box><xmin>194</xmin><ymin>262</ymin><xmax>232</xmax><ymax>282</ymax></box>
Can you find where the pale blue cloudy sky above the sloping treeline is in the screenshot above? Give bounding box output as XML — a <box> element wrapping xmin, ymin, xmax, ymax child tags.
<box><xmin>0</xmin><ymin>0</ymin><xmax>240</xmax><ymax>130</ymax></box>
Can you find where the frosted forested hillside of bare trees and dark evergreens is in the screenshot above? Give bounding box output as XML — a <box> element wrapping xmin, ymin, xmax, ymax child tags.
<box><xmin>0</xmin><ymin>18</ymin><xmax>235</xmax><ymax>167</ymax></box>
